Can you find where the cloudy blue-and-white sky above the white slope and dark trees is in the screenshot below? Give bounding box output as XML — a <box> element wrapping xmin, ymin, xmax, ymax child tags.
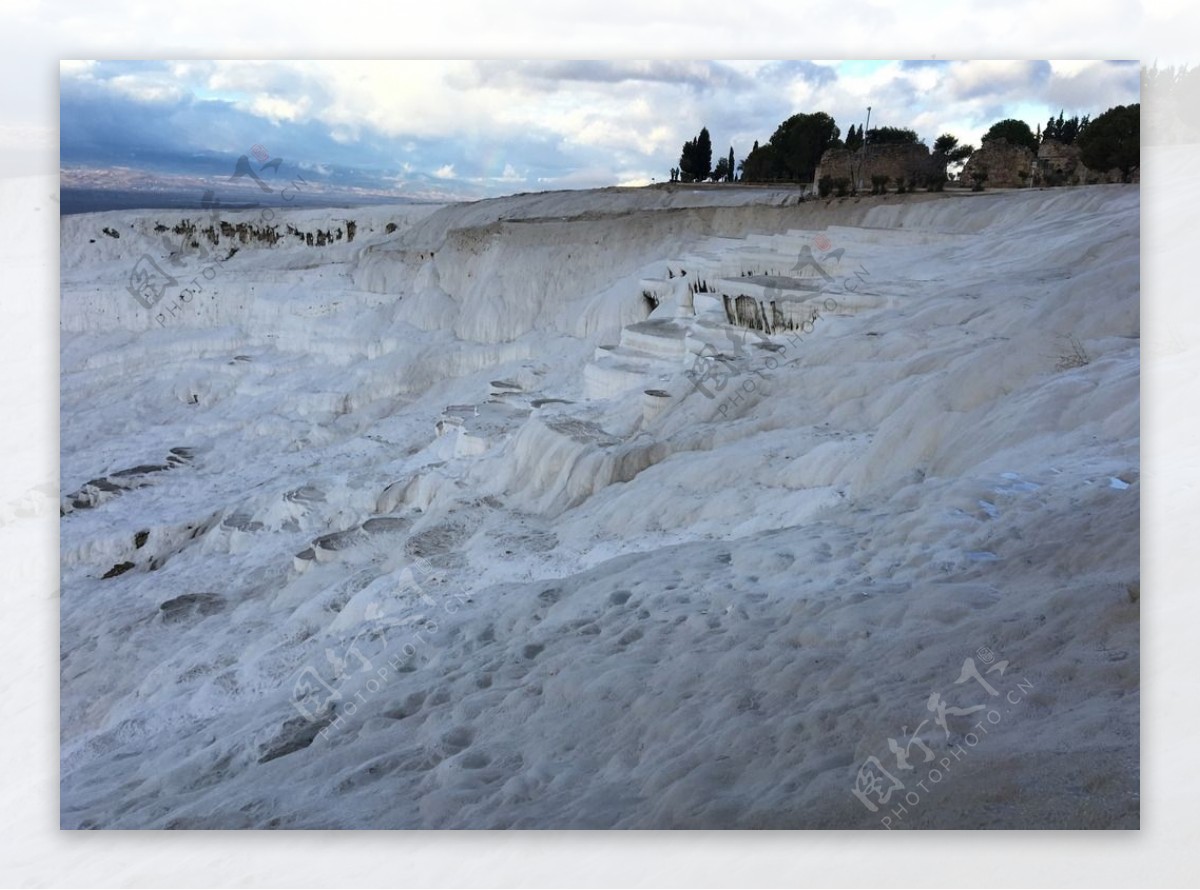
<box><xmin>60</xmin><ymin>60</ymin><xmax>1139</xmax><ymax>198</ymax></box>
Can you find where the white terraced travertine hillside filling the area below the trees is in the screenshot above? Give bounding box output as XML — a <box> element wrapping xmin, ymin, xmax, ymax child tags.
<box><xmin>61</xmin><ymin>186</ymin><xmax>1140</xmax><ymax>828</ymax></box>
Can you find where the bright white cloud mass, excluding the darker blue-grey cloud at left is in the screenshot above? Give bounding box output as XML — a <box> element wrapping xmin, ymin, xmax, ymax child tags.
<box><xmin>62</xmin><ymin>61</ymin><xmax>1136</xmax><ymax>199</ymax></box>
